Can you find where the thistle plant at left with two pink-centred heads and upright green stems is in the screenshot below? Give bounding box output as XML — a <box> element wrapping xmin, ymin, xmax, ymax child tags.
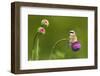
<box><xmin>32</xmin><ymin>19</ymin><xmax>49</xmax><ymax>60</ymax></box>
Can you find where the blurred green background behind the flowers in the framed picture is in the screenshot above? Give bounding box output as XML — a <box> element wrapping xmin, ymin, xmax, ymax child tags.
<box><xmin>28</xmin><ymin>15</ymin><xmax>88</xmax><ymax>60</ymax></box>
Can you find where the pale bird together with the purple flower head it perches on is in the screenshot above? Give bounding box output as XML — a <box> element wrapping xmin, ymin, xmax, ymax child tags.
<box><xmin>69</xmin><ymin>30</ymin><xmax>81</xmax><ymax>51</ymax></box>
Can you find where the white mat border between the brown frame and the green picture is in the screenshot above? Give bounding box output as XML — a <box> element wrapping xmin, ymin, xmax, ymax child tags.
<box><xmin>20</xmin><ymin>6</ymin><xmax>94</xmax><ymax>70</ymax></box>
